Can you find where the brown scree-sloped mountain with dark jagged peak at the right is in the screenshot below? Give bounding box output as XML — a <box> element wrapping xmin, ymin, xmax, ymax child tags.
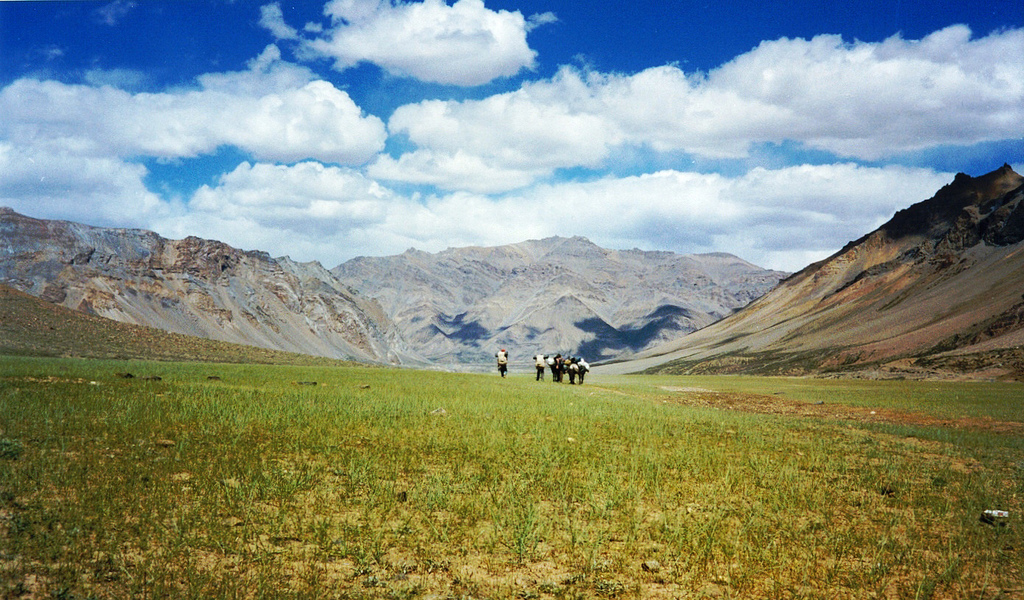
<box><xmin>608</xmin><ymin>165</ymin><xmax>1024</xmax><ymax>379</ymax></box>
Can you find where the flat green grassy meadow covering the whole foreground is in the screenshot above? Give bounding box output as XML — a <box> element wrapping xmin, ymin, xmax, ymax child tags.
<box><xmin>0</xmin><ymin>356</ymin><xmax>1024</xmax><ymax>599</ymax></box>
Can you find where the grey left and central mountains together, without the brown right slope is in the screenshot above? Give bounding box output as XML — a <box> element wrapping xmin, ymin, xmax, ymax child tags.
<box><xmin>0</xmin><ymin>208</ymin><xmax>786</xmax><ymax>369</ymax></box>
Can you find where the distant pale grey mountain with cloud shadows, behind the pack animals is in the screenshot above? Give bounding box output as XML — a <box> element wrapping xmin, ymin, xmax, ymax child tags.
<box><xmin>332</xmin><ymin>238</ymin><xmax>786</xmax><ymax>366</ymax></box>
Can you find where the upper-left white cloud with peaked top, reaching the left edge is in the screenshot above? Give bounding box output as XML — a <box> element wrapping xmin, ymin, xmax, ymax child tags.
<box><xmin>0</xmin><ymin>47</ymin><xmax>385</xmax><ymax>164</ymax></box>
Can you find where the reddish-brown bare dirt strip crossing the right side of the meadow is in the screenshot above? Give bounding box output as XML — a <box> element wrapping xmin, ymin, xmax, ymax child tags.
<box><xmin>600</xmin><ymin>386</ymin><xmax>1024</xmax><ymax>435</ymax></box>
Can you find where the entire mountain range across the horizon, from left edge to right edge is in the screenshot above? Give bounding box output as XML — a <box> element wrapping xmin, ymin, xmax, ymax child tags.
<box><xmin>0</xmin><ymin>165</ymin><xmax>1024</xmax><ymax>380</ymax></box>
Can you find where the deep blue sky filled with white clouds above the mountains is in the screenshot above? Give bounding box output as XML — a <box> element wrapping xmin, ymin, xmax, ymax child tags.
<box><xmin>0</xmin><ymin>0</ymin><xmax>1024</xmax><ymax>271</ymax></box>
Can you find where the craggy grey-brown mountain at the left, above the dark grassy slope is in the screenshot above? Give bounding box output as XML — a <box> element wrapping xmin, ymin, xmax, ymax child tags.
<box><xmin>0</xmin><ymin>208</ymin><xmax>418</xmax><ymax>362</ymax></box>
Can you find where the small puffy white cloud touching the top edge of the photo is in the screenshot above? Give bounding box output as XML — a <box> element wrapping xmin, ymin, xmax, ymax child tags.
<box><xmin>299</xmin><ymin>0</ymin><xmax>553</xmax><ymax>86</ymax></box>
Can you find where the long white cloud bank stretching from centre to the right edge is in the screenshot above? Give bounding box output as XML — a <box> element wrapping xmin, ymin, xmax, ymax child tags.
<box><xmin>375</xmin><ymin>26</ymin><xmax>1024</xmax><ymax>189</ymax></box>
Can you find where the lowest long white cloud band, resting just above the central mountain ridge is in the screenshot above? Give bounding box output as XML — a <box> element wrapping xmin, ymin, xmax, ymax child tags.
<box><xmin>174</xmin><ymin>163</ymin><xmax>952</xmax><ymax>270</ymax></box>
